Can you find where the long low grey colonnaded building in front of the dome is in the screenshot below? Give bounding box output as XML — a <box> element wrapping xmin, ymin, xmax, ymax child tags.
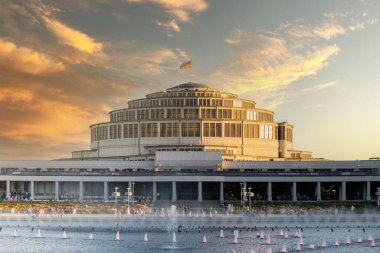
<box><xmin>0</xmin><ymin>151</ymin><xmax>380</xmax><ymax>202</ymax></box>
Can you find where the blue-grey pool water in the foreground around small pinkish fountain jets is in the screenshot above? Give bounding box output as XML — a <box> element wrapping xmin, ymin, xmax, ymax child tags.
<box><xmin>0</xmin><ymin>227</ymin><xmax>380</xmax><ymax>253</ymax></box>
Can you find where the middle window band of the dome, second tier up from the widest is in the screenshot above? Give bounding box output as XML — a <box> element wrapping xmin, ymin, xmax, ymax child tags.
<box><xmin>110</xmin><ymin>108</ymin><xmax>273</xmax><ymax>122</ymax></box>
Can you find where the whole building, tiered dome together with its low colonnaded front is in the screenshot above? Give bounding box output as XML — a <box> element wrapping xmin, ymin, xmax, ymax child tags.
<box><xmin>0</xmin><ymin>83</ymin><xmax>380</xmax><ymax>207</ymax></box>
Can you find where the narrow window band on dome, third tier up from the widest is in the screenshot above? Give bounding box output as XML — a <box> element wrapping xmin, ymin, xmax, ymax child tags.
<box><xmin>128</xmin><ymin>98</ymin><xmax>255</xmax><ymax>108</ymax></box>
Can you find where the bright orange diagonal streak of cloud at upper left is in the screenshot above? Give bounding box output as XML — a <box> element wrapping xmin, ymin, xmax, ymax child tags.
<box><xmin>44</xmin><ymin>17</ymin><xmax>103</xmax><ymax>54</ymax></box>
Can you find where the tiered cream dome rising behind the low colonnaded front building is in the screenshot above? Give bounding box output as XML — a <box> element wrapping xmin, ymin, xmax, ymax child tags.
<box><xmin>72</xmin><ymin>82</ymin><xmax>312</xmax><ymax>161</ymax></box>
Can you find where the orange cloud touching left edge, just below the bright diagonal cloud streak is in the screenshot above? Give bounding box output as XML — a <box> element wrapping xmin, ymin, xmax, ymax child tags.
<box><xmin>0</xmin><ymin>38</ymin><xmax>65</xmax><ymax>75</ymax></box>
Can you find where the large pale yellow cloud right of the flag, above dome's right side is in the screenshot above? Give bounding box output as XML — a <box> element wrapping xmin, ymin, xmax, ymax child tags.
<box><xmin>215</xmin><ymin>36</ymin><xmax>340</xmax><ymax>93</ymax></box>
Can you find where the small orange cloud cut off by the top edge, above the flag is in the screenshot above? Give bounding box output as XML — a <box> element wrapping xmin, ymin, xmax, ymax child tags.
<box><xmin>127</xmin><ymin>0</ymin><xmax>208</xmax><ymax>22</ymax></box>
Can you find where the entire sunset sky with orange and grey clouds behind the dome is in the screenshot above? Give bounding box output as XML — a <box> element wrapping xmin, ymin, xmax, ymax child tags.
<box><xmin>0</xmin><ymin>0</ymin><xmax>380</xmax><ymax>160</ymax></box>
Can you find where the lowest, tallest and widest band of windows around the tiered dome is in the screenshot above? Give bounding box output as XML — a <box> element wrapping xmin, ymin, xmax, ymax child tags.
<box><xmin>91</xmin><ymin>122</ymin><xmax>284</xmax><ymax>141</ymax></box>
